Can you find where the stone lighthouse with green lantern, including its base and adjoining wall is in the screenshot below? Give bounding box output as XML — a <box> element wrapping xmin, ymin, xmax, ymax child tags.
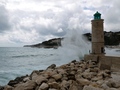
<box><xmin>84</xmin><ymin>12</ymin><xmax>120</xmax><ymax>72</ymax></box>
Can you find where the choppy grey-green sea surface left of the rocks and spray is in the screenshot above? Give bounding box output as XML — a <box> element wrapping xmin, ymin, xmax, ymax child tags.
<box><xmin>0</xmin><ymin>47</ymin><xmax>81</xmax><ymax>85</ymax></box>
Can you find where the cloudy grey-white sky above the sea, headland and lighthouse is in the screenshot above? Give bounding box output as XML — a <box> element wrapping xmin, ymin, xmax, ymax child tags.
<box><xmin>0</xmin><ymin>0</ymin><xmax>120</xmax><ymax>47</ymax></box>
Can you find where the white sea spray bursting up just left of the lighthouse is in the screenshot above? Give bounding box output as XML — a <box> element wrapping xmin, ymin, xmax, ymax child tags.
<box><xmin>59</xmin><ymin>29</ymin><xmax>90</xmax><ymax>62</ymax></box>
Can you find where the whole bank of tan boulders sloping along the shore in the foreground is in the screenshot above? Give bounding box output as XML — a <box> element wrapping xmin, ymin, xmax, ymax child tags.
<box><xmin>0</xmin><ymin>60</ymin><xmax>120</xmax><ymax>90</ymax></box>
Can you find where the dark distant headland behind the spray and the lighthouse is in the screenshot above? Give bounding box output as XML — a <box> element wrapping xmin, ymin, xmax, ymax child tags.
<box><xmin>24</xmin><ymin>31</ymin><xmax>120</xmax><ymax>49</ymax></box>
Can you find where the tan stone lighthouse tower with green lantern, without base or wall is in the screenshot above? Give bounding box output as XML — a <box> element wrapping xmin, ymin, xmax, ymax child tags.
<box><xmin>91</xmin><ymin>12</ymin><xmax>105</xmax><ymax>55</ymax></box>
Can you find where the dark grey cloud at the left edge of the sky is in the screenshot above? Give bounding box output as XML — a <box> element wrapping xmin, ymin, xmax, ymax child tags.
<box><xmin>0</xmin><ymin>5</ymin><xmax>11</xmax><ymax>33</ymax></box>
